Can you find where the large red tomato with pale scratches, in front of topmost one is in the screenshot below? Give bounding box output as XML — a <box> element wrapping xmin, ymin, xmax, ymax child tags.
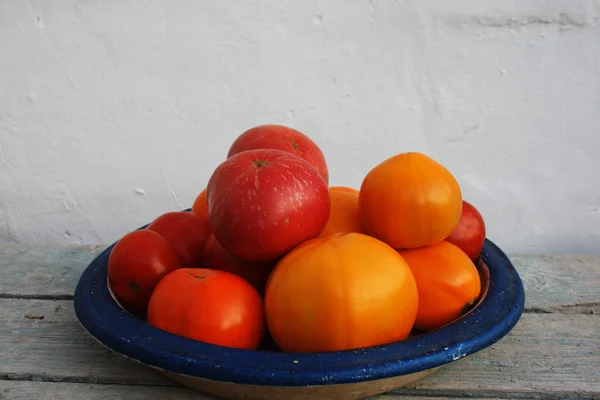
<box><xmin>206</xmin><ymin>150</ymin><xmax>330</xmax><ymax>262</ymax></box>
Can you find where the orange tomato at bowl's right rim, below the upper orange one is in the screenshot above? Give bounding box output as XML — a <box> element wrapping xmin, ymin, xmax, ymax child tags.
<box><xmin>399</xmin><ymin>240</ymin><xmax>481</xmax><ymax>331</ymax></box>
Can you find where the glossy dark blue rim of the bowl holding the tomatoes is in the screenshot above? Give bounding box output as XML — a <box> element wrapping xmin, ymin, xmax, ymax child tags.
<box><xmin>74</xmin><ymin>234</ymin><xmax>525</xmax><ymax>386</ymax></box>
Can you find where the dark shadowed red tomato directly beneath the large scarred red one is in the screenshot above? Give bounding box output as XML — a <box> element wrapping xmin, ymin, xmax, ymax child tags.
<box><xmin>204</xmin><ymin>235</ymin><xmax>275</xmax><ymax>295</ymax></box>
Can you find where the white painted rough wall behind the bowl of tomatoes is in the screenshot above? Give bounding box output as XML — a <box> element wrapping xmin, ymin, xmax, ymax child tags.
<box><xmin>0</xmin><ymin>0</ymin><xmax>600</xmax><ymax>253</ymax></box>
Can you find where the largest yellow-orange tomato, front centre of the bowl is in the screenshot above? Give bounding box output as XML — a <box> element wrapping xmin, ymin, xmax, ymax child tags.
<box><xmin>265</xmin><ymin>233</ymin><xmax>418</xmax><ymax>352</ymax></box>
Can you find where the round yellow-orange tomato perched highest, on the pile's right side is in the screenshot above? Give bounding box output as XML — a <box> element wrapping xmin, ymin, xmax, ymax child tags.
<box><xmin>358</xmin><ymin>152</ymin><xmax>462</xmax><ymax>249</ymax></box>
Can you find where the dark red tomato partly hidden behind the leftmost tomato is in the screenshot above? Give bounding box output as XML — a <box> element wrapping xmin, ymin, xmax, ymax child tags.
<box><xmin>147</xmin><ymin>211</ymin><xmax>210</xmax><ymax>268</ymax></box>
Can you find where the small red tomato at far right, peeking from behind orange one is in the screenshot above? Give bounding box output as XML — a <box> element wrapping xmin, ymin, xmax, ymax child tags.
<box><xmin>446</xmin><ymin>200</ymin><xmax>485</xmax><ymax>261</ymax></box>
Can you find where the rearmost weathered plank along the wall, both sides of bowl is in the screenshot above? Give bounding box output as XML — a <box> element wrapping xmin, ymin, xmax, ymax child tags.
<box><xmin>0</xmin><ymin>245</ymin><xmax>600</xmax><ymax>313</ymax></box>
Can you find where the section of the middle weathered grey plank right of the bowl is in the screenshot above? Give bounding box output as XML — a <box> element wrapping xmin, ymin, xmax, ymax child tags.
<box><xmin>398</xmin><ymin>314</ymin><xmax>600</xmax><ymax>398</ymax></box>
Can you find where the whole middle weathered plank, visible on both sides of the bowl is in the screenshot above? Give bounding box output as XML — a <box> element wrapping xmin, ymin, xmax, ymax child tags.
<box><xmin>0</xmin><ymin>299</ymin><xmax>600</xmax><ymax>398</ymax></box>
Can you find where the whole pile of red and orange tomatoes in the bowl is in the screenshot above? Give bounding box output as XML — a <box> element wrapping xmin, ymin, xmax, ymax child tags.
<box><xmin>108</xmin><ymin>125</ymin><xmax>485</xmax><ymax>352</ymax></box>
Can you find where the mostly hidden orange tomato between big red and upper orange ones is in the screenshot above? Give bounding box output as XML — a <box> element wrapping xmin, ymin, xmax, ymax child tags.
<box><xmin>320</xmin><ymin>186</ymin><xmax>363</xmax><ymax>237</ymax></box>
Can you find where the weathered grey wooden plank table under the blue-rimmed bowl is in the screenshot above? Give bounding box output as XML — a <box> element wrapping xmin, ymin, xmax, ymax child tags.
<box><xmin>0</xmin><ymin>245</ymin><xmax>600</xmax><ymax>400</ymax></box>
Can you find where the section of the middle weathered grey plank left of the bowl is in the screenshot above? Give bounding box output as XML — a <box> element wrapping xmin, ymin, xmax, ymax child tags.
<box><xmin>0</xmin><ymin>299</ymin><xmax>172</xmax><ymax>385</ymax></box>
